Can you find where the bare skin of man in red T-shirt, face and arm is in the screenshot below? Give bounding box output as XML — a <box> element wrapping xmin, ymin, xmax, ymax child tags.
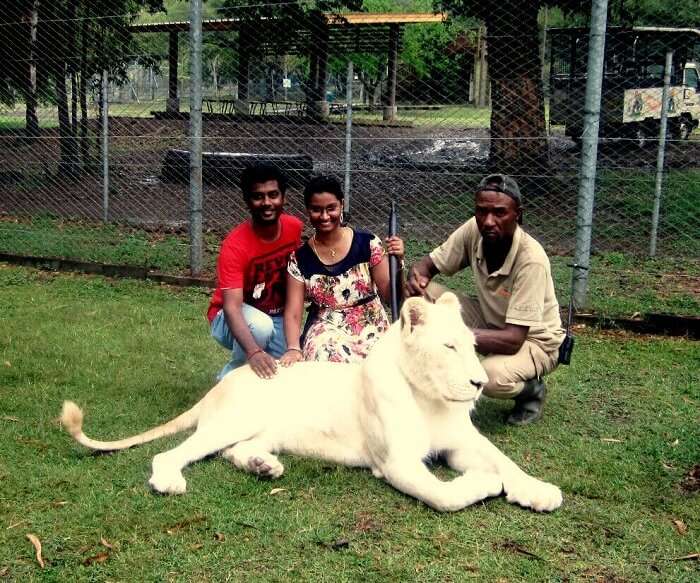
<box><xmin>223</xmin><ymin>180</ymin><xmax>284</xmax><ymax>379</ymax></box>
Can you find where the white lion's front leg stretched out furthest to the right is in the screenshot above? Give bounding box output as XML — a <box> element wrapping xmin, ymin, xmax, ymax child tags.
<box><xmin>447</xmin><ymin>430</ymin><xmax>562</xmax><ymax>512</ymax></box>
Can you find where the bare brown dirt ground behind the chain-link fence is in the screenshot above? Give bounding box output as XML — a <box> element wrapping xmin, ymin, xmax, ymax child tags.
<box><xmin>0</xmin><ymin>117</ymin><xmax>700</xmax><ymax>253</ymax></box>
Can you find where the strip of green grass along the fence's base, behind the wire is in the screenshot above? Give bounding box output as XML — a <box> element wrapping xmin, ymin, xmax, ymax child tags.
<box><xmin>0</xmin><ymin>215</ymin><xmax>700</xmax><ymax>317</ymax></box>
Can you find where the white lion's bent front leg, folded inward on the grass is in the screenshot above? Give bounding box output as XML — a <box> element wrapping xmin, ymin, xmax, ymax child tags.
<box><xmin>381</xmin><ymin>460</ymin><xmax>503</xmax><ymax>512</ymax></box>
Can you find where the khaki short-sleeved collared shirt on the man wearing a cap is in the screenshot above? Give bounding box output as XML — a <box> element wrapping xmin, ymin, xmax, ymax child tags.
<box><xmin>430</xmin><ymin>218</ymin><xmax>564</xmax><ymax>352</ymax></box>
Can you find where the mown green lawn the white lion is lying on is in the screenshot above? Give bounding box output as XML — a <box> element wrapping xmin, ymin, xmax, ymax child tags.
<box><xmin>0</xmin><ymin>265</ymin><xmax>700</xmax><ymax>583</ymax></box>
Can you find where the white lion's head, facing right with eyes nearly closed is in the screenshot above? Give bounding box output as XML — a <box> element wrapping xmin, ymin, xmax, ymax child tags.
<box><xmin>400</xmin><ymin>293</ymin><xmax>488</xmax><ymax>403</ymax></box>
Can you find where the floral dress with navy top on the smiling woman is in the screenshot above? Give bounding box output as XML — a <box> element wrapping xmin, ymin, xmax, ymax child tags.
<box><xmin>287</xmin><ymin>230</ymin><xmax>389</xmax><ymax>362</ymax></box>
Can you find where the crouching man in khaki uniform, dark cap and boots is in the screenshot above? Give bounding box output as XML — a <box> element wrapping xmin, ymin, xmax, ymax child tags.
<box><xmin>406</xmin><ymin>174</ymin><xmax>564</xmax><ymax>425</ymax></box>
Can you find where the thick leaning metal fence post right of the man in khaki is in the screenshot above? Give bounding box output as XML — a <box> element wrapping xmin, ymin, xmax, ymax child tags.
<box><xmin>573</xmin><ymin>0</ymin><xmax>608</xmax><ymax>308</ymax></box>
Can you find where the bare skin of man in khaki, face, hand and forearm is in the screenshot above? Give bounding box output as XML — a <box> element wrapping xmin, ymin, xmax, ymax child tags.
<box><xmin>405</xmin><ymin>190</ymin><xmax>529</xmax><ymax>354</ymax></box>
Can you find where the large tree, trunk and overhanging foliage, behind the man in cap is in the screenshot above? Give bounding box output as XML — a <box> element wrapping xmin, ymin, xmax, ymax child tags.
<box><xmin>437</xmin><ymin>0</ymin><xmax>700</xmax><ymax>177</ymax></box>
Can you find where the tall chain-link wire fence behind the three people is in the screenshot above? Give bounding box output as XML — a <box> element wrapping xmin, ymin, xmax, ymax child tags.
<box><xmin>0</xmin><ymin>0</ymin><xmax>700</xmax><ymax>314</ymax></box>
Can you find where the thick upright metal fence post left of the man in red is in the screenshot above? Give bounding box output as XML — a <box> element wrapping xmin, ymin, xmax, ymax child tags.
<box><xmin>190</xmin><ymin>0</ymin><xmax>202</xmax><ymax>276</ymax></box>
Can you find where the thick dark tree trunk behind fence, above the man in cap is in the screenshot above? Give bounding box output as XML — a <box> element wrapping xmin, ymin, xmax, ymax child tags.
<box><xmin>485</xmin><ymin>0</ymin><xmax>548</xmax><ymax>184</ymax></box>
